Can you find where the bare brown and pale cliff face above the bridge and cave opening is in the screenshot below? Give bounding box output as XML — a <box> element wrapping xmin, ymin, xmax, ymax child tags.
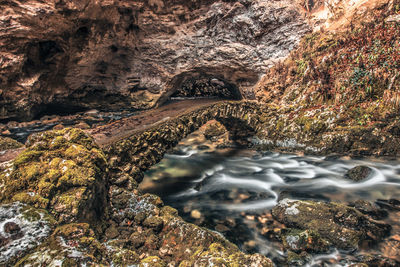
<box><xmin>0</xmin><ymin>0</ymin><xmax>309</xmax><ymax>120</ymax></box>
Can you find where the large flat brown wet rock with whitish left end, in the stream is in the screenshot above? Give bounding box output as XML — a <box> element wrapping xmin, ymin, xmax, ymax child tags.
<box><xmin>272</xmin><ymin>199</ymin><xmax>391</xmax><ymax>250</ymax></box>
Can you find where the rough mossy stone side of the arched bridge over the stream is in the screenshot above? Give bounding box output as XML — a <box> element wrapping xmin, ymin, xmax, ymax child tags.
<box><xmin>104</xmin><ymin>101</ymin><xmax>261</xmax><ymax>183</ymax></box>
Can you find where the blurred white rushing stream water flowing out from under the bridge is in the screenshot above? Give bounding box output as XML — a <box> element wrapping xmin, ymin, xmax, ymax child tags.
<box><xmin>141</xmin><ymin>132</ymin><xmax>400</xmax><ymax>266</ymax></box>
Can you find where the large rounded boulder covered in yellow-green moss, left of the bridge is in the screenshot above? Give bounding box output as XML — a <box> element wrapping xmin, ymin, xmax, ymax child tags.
<box><xmin>0</xmin><ymin>128</ymin><xmax>108</xmax><ymax>223</ymax></box>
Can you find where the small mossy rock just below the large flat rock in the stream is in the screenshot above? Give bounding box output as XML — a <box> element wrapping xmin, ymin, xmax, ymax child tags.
<box><xmin>281</xmin><ymin>229</ymin><xmax>330</xmax><ymax>253</ymax></box>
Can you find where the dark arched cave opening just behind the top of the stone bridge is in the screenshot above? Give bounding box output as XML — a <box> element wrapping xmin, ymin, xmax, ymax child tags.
<box><xmin>171</xmin><ymin>74</ymin><xmax>242</xmax><ymax>100</ymax></box>
